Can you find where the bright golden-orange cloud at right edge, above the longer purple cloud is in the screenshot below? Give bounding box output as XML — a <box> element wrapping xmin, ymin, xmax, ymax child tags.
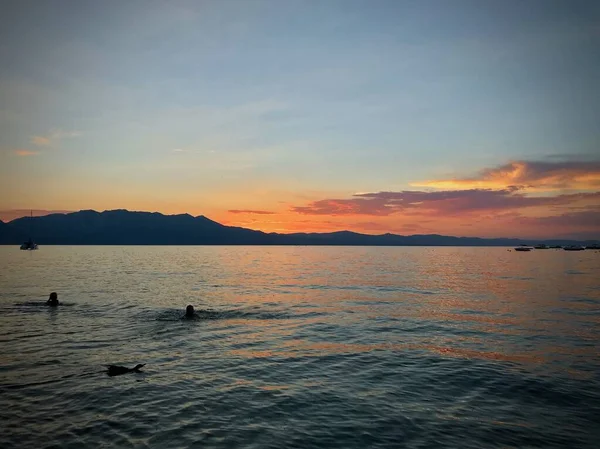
<box><xmin>411</xmin><ymin>161</ymin><xmax>600</xmax><ymax>191</ymax></box>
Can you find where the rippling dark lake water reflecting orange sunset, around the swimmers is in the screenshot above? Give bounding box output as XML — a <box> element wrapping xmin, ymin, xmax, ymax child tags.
<box><xmin>0</xmin><ymin>246</ymin><xmax>600</xmax><ymax>449</ymax></box>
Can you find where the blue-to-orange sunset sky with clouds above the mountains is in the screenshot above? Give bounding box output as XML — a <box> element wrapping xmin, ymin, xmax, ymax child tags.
<box><xmin>0</xmin><ymin>0</ymin><xmax>600</xmax><ymax>238</ymax></box>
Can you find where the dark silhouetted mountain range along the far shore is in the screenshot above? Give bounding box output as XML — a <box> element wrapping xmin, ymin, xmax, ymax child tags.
<box><xmin>0</xmin><ymin>210</ymin><xmax>597</xmax><ymax>246</ymax></box>
